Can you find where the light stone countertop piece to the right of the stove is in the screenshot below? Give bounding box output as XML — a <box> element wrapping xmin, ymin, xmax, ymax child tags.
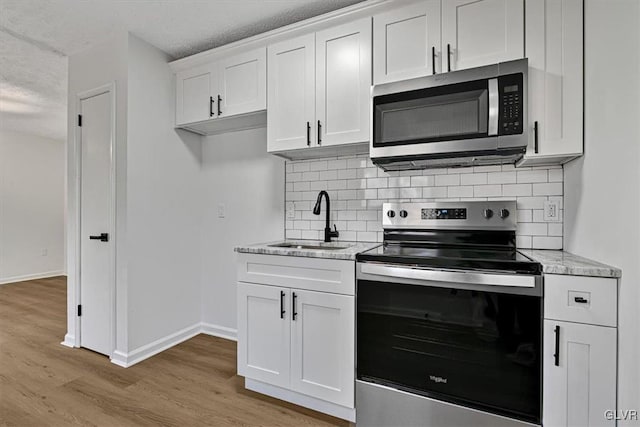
<box><xmin>518</xmin><ymin>249</ymin><xmax>622</xmax><ymax>278</ymax></box>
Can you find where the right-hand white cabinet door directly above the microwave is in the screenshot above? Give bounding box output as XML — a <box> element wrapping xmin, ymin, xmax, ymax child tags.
<box><xmin>442</xmin><ymin>0</ymin><xmax>524</xmax><ymax>71</ymax></box>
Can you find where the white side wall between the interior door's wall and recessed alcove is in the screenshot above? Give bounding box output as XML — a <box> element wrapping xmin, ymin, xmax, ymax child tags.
<box><xmin>127</xmin><ymin>36</ymin><xmax>202</xmax><ymax>351</ymax></box>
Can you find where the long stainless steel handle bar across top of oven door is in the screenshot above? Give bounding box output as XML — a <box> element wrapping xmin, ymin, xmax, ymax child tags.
<box><xmin>360</xmin><ymin>263</ymin><xmax>536</xmax><ymax>288</ymax></box>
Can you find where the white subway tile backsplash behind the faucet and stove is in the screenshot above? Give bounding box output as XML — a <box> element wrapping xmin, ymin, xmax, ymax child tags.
<box><xmin>285</xmin><ymin>155</ymin><xmax>564</xmax><ymax>249</ymax></box>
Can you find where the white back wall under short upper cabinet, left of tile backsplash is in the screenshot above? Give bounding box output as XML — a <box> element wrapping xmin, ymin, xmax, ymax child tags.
<box><xmin>202</xmin><ymin>128</ymin><xmax>284</xmax><ymax>336</ymax></box>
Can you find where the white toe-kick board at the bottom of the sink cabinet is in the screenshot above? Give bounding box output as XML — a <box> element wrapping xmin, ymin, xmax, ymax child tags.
<box><xmin>244</xmin><ymin>378</ymin><xmax>356</xmax><ymax>423</ymax></box>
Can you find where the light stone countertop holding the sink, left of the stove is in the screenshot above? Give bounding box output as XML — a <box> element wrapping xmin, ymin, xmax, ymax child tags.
<box><xmin>234</xmin><ymin>240</ymin><xmax>382</xmax><ymax>261</ymax></box>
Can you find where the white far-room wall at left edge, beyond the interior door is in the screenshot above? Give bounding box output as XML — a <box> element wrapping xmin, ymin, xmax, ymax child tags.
<box><xmin>0</xmin><ymin>130</ymin><xmax>65</xmax><ymax>283</ymax></box>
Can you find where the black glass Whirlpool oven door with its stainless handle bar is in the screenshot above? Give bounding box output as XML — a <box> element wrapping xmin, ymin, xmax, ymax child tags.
<box><xmin>357</xmin><ymin>263</ymin><xmax>542</xmax><ymax>424</ymax></box>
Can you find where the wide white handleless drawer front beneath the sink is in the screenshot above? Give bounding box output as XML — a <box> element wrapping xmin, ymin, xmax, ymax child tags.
<box><xmin>238</xmin><ymin>253</ymin><xmax>356</xmax><ymax>295</ymax></box>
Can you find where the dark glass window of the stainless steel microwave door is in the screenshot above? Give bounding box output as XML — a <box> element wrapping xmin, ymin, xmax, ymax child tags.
<box><xmin>374</xmin><ymin>80</ymin><xmax>489</xmax><ymax>147</ymax></box>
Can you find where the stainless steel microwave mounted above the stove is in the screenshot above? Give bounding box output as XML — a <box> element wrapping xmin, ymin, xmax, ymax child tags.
<box><xmin>370</xmin><ymin>58</ymin><xmax>528</xmax><ymax>170</ymax></box>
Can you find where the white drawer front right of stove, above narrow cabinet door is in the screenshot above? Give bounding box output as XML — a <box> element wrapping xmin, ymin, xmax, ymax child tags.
<box><xmin>544</xmin><ymin>274</ymin><xmax>618</xmax><ymax>327</ymax></box>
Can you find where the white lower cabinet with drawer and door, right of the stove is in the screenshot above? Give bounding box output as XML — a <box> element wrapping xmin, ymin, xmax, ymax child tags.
<box><xmin>542</xmin><ymin>274</ymin><xmax>618</xmax><ymax>427</ymax></box>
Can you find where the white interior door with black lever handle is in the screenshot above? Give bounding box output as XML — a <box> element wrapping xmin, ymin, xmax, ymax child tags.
<box><xmin>79</xmin><ymin>92</ymin><xmax>113</xmax><ymax>355</ymax></box>
